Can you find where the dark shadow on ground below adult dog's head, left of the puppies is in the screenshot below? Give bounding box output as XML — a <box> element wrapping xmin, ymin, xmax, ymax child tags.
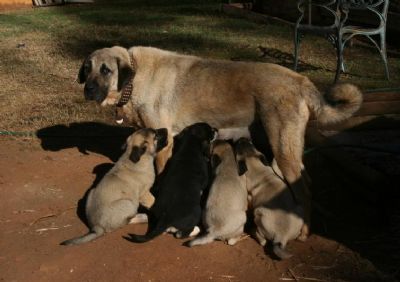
<box><xmin>36</xmin><ymin>122</ymin><xmax>135</xmax><ymax>162</ymax></box>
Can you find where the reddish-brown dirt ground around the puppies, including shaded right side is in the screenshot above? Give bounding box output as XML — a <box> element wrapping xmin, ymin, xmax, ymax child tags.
<box><xmin>0</xmin><ymin>123</ymin><xmax>400</xmax><ymax>281</ymax></box>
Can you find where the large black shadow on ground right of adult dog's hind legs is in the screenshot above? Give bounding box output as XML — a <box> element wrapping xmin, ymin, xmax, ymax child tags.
<box><xmin>304</xmin><ymin>115</ymin><xmax>400</xmax><ymax>278</ymax></box>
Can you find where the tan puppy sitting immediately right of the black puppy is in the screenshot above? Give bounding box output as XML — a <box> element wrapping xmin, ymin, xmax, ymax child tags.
<box><xmin>187</xmin><ymin>141</ymin><xmax>247</xmax><ymax>247</ymax></box>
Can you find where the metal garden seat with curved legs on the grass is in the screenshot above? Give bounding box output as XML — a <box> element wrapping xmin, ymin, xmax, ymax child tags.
<box><xmin>294</xmin><ymin>0</ymin><xmax>389</xmax><ymax>82</ymax></box>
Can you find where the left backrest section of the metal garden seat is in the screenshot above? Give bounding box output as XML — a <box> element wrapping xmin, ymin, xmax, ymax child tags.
<box><xmin>296</xmin><ymin>0</ymin><xmax>340</xmax><ymax>28</ymax></box>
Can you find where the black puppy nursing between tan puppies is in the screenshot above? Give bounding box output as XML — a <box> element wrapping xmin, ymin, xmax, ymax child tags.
<box><xmin>126</xmin><ymin>123</ymin><xmax>217</xmax><ymax>243</ymax></box>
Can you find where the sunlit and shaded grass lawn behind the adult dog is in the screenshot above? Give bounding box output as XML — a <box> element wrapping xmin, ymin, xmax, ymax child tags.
<box><xmin>0</xmin><ymin>0</ymin><xmax>400</xmax><ymax>130</ymax></box>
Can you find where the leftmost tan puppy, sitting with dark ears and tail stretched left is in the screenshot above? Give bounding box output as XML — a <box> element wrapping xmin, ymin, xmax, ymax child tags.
<box><xmin>61</xmin><ymin>128</ymin><xmax>168</xmax><ymax>245</ymax></box>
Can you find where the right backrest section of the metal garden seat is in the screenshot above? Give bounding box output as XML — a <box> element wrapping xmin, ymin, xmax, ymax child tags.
<box><xmin>339</xmin><ymin>0</ymin><xmax>389</xmax><ymax>28</ymax></box>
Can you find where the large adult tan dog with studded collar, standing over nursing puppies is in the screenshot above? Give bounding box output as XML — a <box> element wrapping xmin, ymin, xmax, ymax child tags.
<box><xmin>78</xmin><ymin>46</ymin><xmax>362</xmax><ymax>238</ymax></box>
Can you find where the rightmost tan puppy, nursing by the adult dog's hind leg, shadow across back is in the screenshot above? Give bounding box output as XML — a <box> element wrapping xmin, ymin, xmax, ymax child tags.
<box><xmin>235</xmin><ymin>138</ymin><xmax>304</xmax><ymax>259</ymax></box>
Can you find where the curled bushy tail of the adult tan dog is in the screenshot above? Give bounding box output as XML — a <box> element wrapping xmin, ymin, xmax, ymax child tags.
<box><xmin>312</xmin><ymin>83</ymin><xmax>363</xmax><ymax>124</ymax></box>
